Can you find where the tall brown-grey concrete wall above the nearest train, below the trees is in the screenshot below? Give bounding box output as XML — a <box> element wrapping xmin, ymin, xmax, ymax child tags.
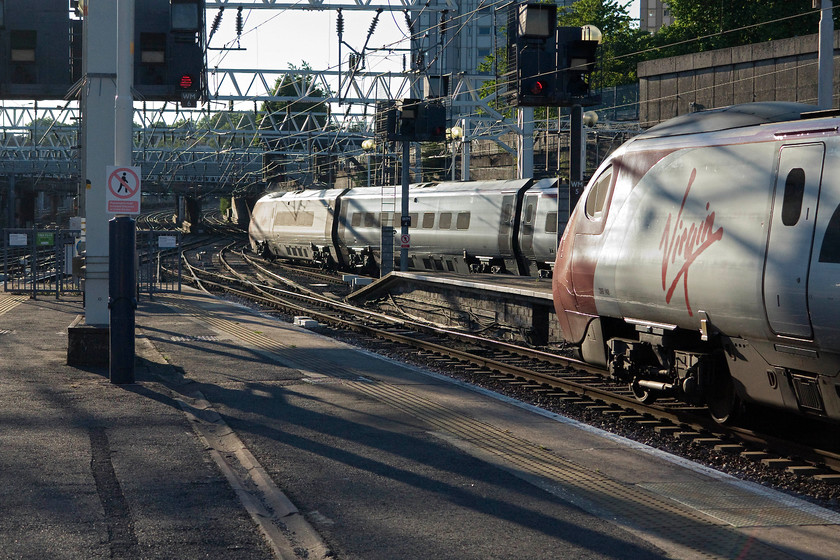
<box><xmin>638</xmin><ymin>31</ymin><xmax>840</xmax><ymax>128</ymax></box>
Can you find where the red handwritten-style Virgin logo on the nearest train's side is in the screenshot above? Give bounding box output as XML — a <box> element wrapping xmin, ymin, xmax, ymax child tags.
<box><xmin>659</xmin><ymin>169</ymin><xmax>723</xmax><ymax>316</ymax></box>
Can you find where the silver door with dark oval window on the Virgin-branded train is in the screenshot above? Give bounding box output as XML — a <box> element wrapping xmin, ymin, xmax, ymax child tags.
<box><xmin>764</xmin><ymin>143</ymin><xmax>825</xmax><ymax>338</ymax></box>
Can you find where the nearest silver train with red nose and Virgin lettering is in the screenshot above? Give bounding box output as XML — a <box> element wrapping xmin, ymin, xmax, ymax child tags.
<box><xmin>552</xmin><ymin>102</ymin><xmax>840</xmax><ymax>423</ymax></box>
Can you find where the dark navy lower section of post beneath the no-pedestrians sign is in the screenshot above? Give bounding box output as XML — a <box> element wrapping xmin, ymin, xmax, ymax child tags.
<box><xmin>108</xmin><ymin>216</ymin><xmax>137</xmax><ymax>384</ymax></box>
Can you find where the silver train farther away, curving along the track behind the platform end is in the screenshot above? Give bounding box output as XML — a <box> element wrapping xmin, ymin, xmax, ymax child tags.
<box><xmin>248</xmin><ymin>178</ymin><xmax>569</xmax><ymax>277</ymax></box>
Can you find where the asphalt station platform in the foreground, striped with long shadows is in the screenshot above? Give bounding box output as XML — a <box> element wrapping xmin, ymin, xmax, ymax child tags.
<box><xmin>0</xmin><ymin>291</ymin><xmax>840</xmax><ymax>560</ymax></box>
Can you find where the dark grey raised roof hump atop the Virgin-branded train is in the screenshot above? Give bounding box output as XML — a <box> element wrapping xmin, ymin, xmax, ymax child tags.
<box><xmin>636</xmin><ymin>101</ymin><xmax>817</xmax><ymax>140</ymax></box>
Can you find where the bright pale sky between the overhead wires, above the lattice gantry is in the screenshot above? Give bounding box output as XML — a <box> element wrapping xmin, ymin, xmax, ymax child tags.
<box><xmin>206</xmin><ymin>0</ymin><xmax>639</xmax><ymax>104</ymax></box>
